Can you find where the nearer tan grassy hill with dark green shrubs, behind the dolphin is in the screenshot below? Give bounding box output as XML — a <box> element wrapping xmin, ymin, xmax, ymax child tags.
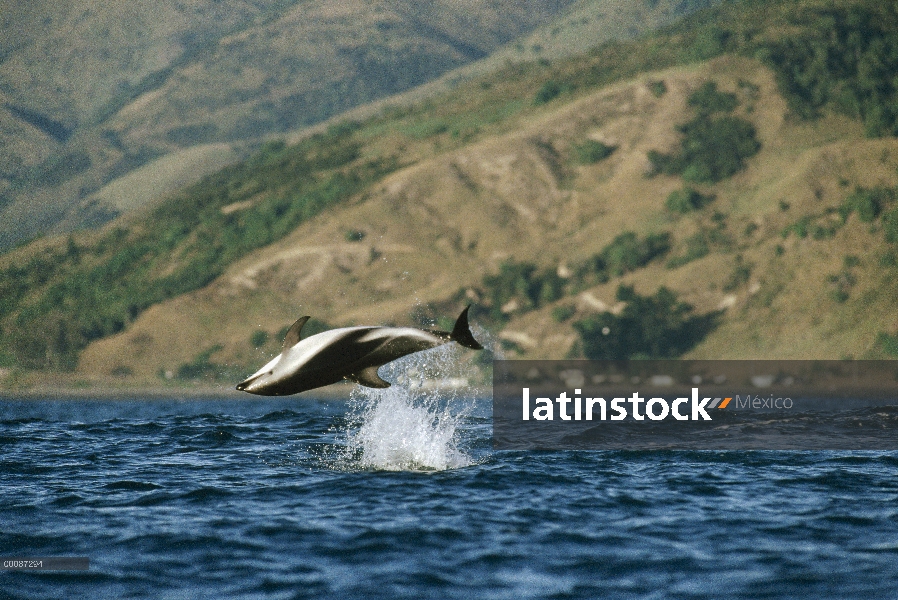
<box><xmin>0</xmin><ymin>1</ymin><xmax>898</xmax><ymax>392</ymax></box>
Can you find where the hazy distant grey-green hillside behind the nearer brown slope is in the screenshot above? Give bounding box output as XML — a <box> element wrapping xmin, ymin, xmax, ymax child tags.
<box><xmin>0</xmin><ymin>0</ymin><xmax>712</xmax><ymax>249</ymax></box>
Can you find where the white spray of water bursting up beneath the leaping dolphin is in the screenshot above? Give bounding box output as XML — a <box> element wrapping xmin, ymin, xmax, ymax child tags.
<box><xmin>327</xmin><ymin>336</ymin><xmax>490</xmax><ymax>471</ymax></box>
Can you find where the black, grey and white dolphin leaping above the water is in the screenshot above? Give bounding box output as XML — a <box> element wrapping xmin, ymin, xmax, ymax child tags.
<box><xmin>237</xmin><ymin>306</ymin><xmax>483</xmax><ymax>396</ymax></box>
